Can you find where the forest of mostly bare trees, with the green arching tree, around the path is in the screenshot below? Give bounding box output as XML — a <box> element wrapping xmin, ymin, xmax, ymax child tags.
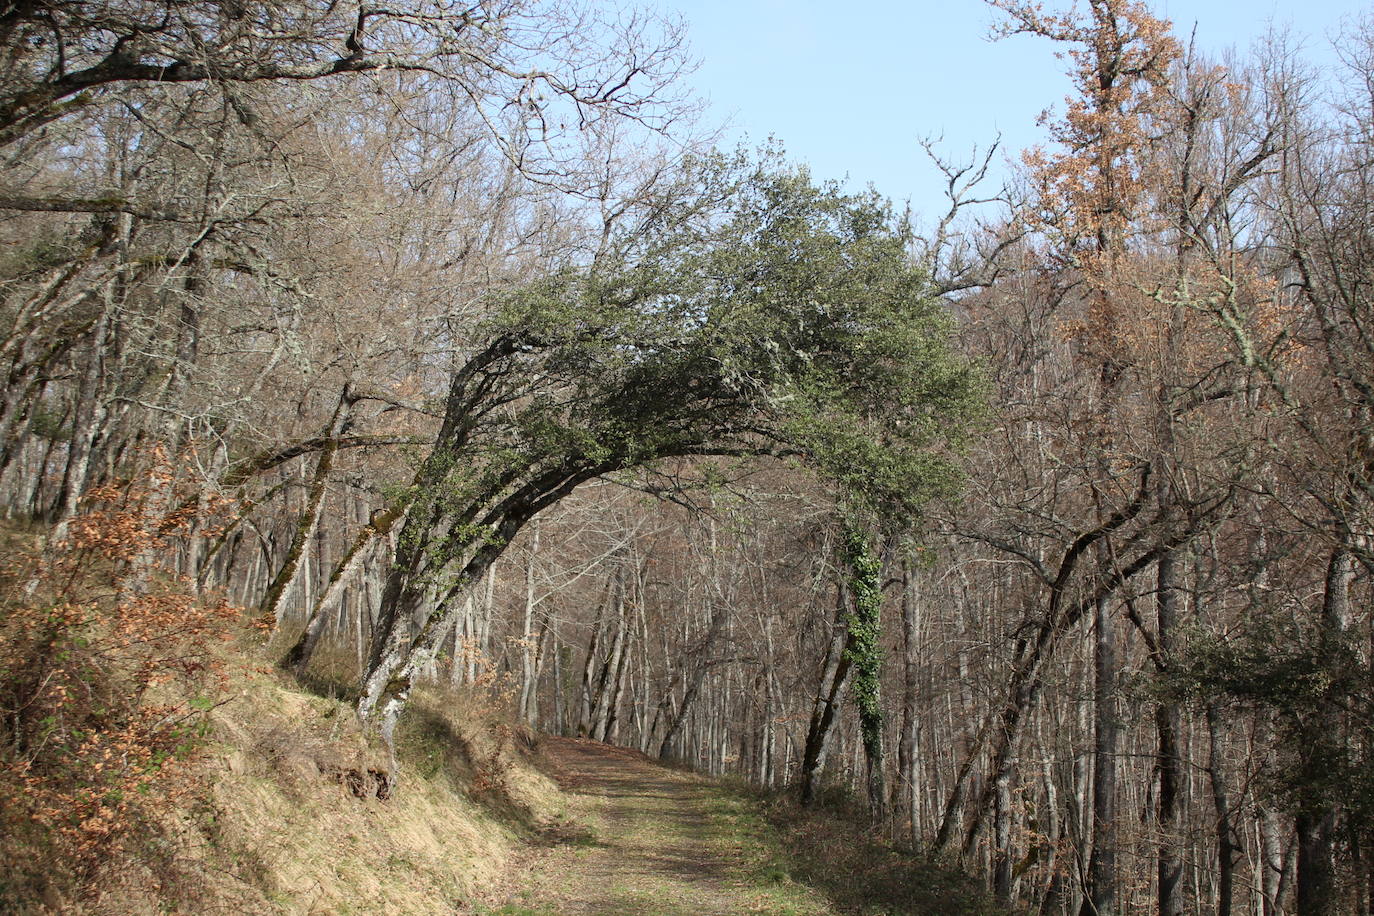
<box><xmin>0</xmin><ymin>0</ymin><xmax>1374</xmax><ymax>916</ymax></box>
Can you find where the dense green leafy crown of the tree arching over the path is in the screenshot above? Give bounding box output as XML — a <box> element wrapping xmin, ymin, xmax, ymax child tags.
<box><xmin>414</xmin><ymin>157</ymin><xmax>982</xmax><ymax>579</ymax></box>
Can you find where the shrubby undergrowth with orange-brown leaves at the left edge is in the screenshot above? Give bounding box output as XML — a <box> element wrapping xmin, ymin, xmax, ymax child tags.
<box><xmin>0</xmin><ymin>466</ymin><xmax>239</xmax><ymax>912</ymax></box>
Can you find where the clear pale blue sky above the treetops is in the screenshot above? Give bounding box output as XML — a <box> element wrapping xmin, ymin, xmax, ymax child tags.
<box><xmin>676</xmin><ymin>0</ymin><xmax>1370</xmax><ymax>216</ymax></box>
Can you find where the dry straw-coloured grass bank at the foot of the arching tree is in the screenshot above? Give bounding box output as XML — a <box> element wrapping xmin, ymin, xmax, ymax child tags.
<box><xmin>167</xmin><ymin>661</ymin><xmax>574</xmax><ymax>913</ymax></box>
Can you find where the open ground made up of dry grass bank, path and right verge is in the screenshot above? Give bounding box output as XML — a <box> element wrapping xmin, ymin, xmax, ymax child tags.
<box><xmin>8</xmin><ymin>620</ymin><xmax>996</xmax><ymax>916</ymax></box>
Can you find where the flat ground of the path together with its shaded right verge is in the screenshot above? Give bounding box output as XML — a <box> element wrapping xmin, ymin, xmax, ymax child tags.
<box><xmin>478</xmin><ymin>737</ymin><xmax>998</xmax><ymax>916</ymax></box>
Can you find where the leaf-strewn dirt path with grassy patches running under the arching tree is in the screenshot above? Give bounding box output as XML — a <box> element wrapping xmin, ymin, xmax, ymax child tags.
<box><xmin>495</xmin><ymin>737</ymin><xmax>835</xmax><ymax>916</ymax></box>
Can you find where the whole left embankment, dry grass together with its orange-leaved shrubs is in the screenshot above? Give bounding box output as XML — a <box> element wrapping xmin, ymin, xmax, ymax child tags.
<box><xmin>0</xmin><ymin>494</ymin><xmax>563</xmax><ymax>916</ymax></box>
